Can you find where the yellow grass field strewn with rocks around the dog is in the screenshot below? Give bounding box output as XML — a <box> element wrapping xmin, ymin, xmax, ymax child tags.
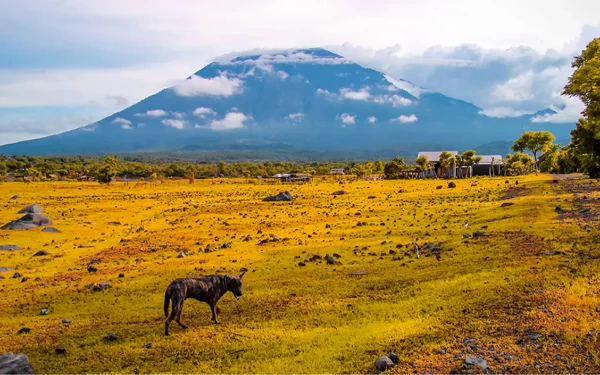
<box><xmin>0</xmin><ymin>175</ymin><xmax>600</xmax><ymax>375</ymax></box>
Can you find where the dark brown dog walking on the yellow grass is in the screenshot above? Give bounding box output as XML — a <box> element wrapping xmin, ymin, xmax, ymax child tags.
<box><xmin>165</xmin><ymin>271</ymin><xmax>246</xmax><ymax>336</ymax></box>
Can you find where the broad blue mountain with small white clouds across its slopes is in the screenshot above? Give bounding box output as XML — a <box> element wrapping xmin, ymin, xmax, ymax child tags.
<box><xmin>0</xmin><ymin>48</ymin><xmax>572</xmax><ymax>156</ymax></box>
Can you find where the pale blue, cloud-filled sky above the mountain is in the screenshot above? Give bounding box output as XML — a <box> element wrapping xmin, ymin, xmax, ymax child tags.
<box><xmin>0</xmin><ymin>0</ymin><xmax>600</xmax><ymax>144</ymax></box>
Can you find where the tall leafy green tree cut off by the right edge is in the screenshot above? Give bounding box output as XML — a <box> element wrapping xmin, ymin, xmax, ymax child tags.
<box><xmin>563</xmin><ymin>38</ymin><xmax>600</xmax><ymax>178</ymax></box>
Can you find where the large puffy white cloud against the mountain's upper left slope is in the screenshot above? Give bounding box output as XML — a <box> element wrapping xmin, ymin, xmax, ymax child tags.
<box><xmin>173</xmin><ymin>73</ymin><xmax>243</xmax><ymax>96</ymax></box>
